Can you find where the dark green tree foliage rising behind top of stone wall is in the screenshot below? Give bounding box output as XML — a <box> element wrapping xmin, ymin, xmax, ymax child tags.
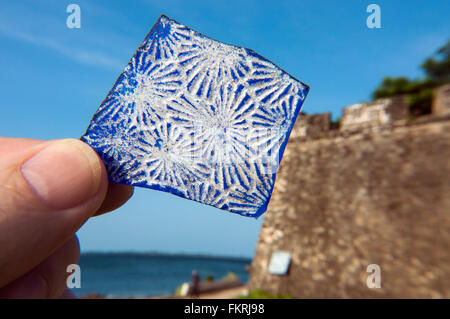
<box><xmin>372</xmin><ymin>41</ymin><xmax>450</xmax><ymax>116</ymax></box>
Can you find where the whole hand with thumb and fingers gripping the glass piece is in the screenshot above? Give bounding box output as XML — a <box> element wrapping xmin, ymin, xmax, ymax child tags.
<box><xmin>0</xmin><ymin>137</ymin><xmax>133</xmax><ymax>298</ymax></box>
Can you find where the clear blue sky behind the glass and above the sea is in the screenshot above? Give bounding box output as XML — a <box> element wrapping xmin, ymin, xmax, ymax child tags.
<box><xmin>0</xmin><ymin>0</ymin><xmax>450</xmax><ymax>257</ymax></box>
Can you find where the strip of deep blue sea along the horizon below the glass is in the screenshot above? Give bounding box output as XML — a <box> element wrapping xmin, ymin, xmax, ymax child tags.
<box><xmin>72</xmin><ymin>253</ymin><xmax>251</xmax><ymax>298</ymax></box>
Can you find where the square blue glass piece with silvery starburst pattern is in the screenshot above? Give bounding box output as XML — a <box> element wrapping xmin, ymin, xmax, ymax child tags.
<box><xmin>81</xmin><ymin>16</ymin><xmax>309</xmax><ymax>217</ymax></box>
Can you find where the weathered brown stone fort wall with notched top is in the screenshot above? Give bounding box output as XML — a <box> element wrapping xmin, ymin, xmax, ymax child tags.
<box><xmin>249</xmin><ymin>85</ymin><xmax>450</xmax><ymax>298</ymax></box>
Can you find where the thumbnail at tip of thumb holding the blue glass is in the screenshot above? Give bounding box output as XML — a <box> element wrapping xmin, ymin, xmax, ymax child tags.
<box><xmin>21</xmin><ymin>139</ymin><xmax>102</xmax><ymax>209</ymax></box>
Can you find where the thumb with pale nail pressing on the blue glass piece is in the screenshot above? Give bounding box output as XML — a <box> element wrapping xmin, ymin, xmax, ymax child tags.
<box><xmin>0</xmin><ymin>138</ymin><xmax>108</xmax><ymax>287</ymax></box>
